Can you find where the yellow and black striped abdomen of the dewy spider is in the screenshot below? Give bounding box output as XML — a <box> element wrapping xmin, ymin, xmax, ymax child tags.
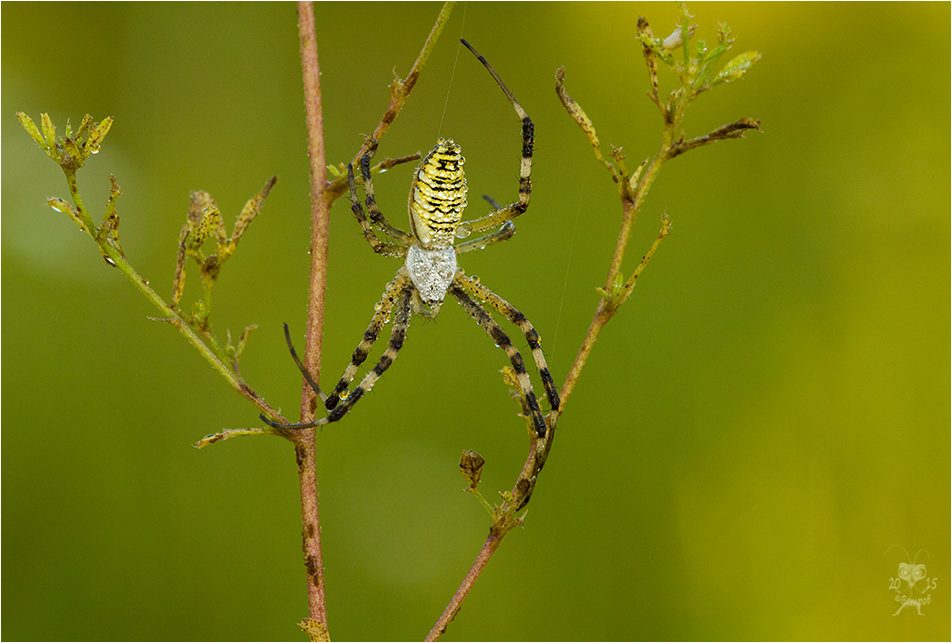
<box><xmin>410</xmin><ymin>138</ymin><xmax>466</xmax><ymax>250</ymax></box>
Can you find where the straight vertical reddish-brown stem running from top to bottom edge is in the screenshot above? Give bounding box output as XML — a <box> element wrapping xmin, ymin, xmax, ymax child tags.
<box><xmin>292</xmin><ymin>1</ymin><xmax>330</xmax><ymax>641</ymax></box>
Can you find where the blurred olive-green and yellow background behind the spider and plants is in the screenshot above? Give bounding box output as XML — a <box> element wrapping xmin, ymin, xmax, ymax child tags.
<box><xmin>0</xmin><ymin>3</ymin><xmax>952</xmax><ymax>640</ymax></box>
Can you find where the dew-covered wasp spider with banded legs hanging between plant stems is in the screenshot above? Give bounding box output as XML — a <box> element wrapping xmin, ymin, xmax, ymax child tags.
<box><xmin>262</xmin><ymin>40</ymin><xmax>559</xmax><ymax>437</ymax></box>
